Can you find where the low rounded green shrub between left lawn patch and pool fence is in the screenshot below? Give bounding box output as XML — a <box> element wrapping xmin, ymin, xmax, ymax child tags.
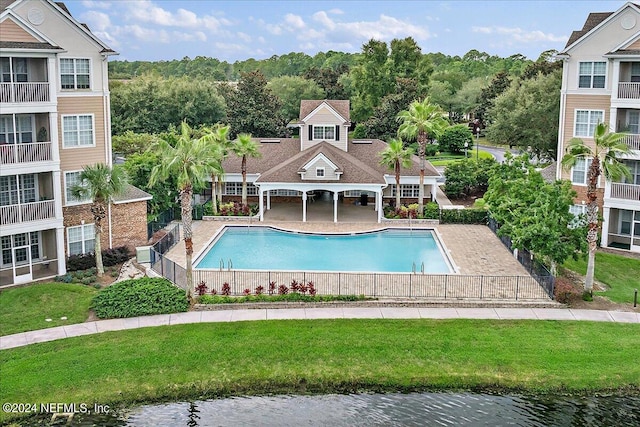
<box><xmin>92</xmin><ymin>277</ymin><xmax>189</xmax><ymax>319</ymax></box>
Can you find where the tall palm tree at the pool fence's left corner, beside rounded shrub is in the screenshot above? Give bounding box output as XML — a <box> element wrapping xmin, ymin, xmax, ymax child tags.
<box><xmin>149</xmin><ymin>122</ymin><xmax>222</xmax><ymax>298</ymax></box>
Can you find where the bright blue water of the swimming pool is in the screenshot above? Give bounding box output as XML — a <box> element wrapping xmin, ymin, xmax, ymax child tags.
<box><xmin>195</xmin><ymin>227</ymin><xmax>451</xmax><ymax>273</ymax></box>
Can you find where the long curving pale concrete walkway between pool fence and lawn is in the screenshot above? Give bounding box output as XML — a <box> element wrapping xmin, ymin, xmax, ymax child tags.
<box><xmin>0</xmin><ymin>307</ymin><xmax>640</xmax><ymax>350</ymax></box>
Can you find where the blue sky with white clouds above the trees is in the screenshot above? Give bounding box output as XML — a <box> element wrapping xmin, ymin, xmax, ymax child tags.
<box><xmin>65</xmin><ymin>0</ymin><xmax>626</xmax><ymax>62</ymax></box>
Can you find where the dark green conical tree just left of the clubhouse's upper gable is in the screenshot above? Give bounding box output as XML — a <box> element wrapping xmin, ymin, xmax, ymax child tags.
<box><xmin>225</xmin><ymin>71</ymin><xmax>286</xmax><ymax>138</ymax></box>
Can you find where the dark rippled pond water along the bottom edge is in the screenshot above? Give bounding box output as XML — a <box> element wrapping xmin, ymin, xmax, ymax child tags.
<box><xmin>37</xmin><ymin>392</ymin><xmax>640</xmax><ymax>427</ymax></box>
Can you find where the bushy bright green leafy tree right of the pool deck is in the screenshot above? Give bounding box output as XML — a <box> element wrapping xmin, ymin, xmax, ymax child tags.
<box><xmin>484</xmin><ymin>154</ymin><xmax>586</xmax><ymax>273</ymax></box>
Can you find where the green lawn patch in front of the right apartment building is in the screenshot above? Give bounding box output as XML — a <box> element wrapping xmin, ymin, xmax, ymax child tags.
<box><xmin>563</xmin><ymin>252</ymin><xmax>640</xmax><ymax>303</ymax></box>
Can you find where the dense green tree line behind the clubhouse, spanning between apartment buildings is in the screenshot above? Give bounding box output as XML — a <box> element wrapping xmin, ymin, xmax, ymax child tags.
<box><xmin>109</xmin><ymin>37</ymin><xmax>561</xmax><ymax>158</ymax></box>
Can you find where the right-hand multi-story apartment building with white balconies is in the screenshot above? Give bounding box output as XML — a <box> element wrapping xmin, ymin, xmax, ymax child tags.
<box><xmin>556</xmin><ymin>2</ymin><xmax>640</xmax><ymax>252</ymax></box>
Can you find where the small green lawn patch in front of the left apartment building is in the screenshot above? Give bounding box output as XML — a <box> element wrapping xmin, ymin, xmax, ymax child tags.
<box><xmin>0</xmin><ymin>283</ymin><xmax>97</xmax><ymax>335</ymax></box>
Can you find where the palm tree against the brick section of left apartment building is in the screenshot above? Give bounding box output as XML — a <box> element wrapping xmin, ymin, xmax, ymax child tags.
<box><xmin>70</xmin><ymin>163</ymin><xmax>127</xmax><ymax>277</ymax></box>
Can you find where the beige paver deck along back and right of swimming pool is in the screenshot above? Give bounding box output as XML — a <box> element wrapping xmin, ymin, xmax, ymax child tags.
<box><xmin>167</xmin><ymin>220</ymin><xmax>528</xmax><ymax>276</ymax></box>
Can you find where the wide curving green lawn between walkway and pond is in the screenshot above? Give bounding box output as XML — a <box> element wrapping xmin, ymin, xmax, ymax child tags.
<box><xmin>0</xmin><ymin>319</ymin><xmax>640</xmax><ymax>417</ymax></box>
